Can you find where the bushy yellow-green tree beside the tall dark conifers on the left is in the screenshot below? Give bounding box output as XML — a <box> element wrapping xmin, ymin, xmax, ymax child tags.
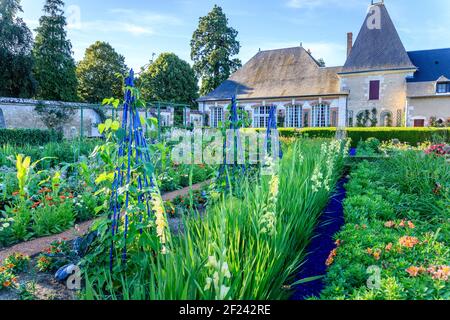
<box><xmin>77</xmin><ymin>41</ymin><xmax>127</xmax><ymax>103</ymax></box>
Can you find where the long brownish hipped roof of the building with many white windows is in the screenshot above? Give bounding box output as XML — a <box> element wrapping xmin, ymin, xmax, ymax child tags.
<box><xmin>198</xmin><ymin>47</ymin><xmax>342</xmax><ymax>102</ymax></box>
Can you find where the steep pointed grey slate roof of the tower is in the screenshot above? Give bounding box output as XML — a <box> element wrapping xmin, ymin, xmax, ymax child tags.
<box><xmin>342</xmin><ymin>3</ymin><xmax>415</xmax><ymax>73</ymax></box>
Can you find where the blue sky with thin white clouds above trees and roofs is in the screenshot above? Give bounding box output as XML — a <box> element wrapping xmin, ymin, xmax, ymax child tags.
<box><xmin>22</xmin><ymin>0</ymin><xmax>450</xmax><ymax>69</ymax></box>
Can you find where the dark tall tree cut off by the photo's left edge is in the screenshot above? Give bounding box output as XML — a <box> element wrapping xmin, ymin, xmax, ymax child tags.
<box><xmin>0</xmin><ymin>0</ymin><xmax>36</xmax><ymax>98</ymax></box>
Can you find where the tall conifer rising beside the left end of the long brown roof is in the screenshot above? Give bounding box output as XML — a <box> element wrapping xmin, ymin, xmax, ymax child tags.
<box><xmin>191</xmin><ymin>5</ymin><xmax>241</xmax><ymax>95</ymax></box>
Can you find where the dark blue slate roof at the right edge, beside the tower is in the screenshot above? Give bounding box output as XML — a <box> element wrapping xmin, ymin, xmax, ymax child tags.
<box><xmin>408</xmin><ymin>48</ymin><xmax>450</xmax><ymax>82</ymax></box>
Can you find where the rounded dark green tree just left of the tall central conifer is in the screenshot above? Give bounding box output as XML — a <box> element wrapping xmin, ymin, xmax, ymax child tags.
<box><xmin>139</xmin><ymin>53</ymin><xmax>198</xmax><ymax>104</ymax></box>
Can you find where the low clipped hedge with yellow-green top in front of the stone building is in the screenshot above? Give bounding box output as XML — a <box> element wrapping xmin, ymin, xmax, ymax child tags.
<box><xmin>279</xmin><ymin>128</ymin><xmax>450</xmax><ymax>147</ymax></box>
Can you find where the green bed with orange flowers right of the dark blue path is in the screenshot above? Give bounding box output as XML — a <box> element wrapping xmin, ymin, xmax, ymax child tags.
<box><xmin>321</xmin><ymin>151</ymin><xmax>450</xmax><ymax>300</ymax></box>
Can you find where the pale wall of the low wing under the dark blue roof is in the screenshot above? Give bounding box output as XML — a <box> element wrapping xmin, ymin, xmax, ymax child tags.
<box><xmin>407</xmin><ymin>95</ymin><xmax>450</xmax><ymax>127</ymax></box>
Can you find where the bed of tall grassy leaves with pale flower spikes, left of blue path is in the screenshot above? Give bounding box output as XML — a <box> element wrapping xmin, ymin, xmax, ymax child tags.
<box><xmin>82</xmin><ymin>140</ymin><xmax>347</xmax><ymax>300</ymax></box>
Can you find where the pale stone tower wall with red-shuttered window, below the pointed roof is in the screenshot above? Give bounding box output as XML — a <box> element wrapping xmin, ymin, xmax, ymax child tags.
<box><xmin>341</xmin><ymin>72</ymin><xmax>411</xmax><ymax>126</ymax></box>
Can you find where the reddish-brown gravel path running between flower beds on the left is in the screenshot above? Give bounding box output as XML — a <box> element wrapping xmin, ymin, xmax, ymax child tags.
<box><xmin>0</xmin><ymin>181</ymin><xmax>211</xmax><ymax>263</ymax></box>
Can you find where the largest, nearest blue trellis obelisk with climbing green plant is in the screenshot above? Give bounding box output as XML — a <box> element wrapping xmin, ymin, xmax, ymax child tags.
<box><xmin>110</xmin><ymin>70</ymin><xmax>154</xmax><ymax>269</ymax></box>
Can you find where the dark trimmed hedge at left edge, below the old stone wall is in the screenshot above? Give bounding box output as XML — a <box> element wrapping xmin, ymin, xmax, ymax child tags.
<box><xmin>0</xmin><ymin>129</ymin><xmax>63</xmax><ymax>146</ymax></box>
